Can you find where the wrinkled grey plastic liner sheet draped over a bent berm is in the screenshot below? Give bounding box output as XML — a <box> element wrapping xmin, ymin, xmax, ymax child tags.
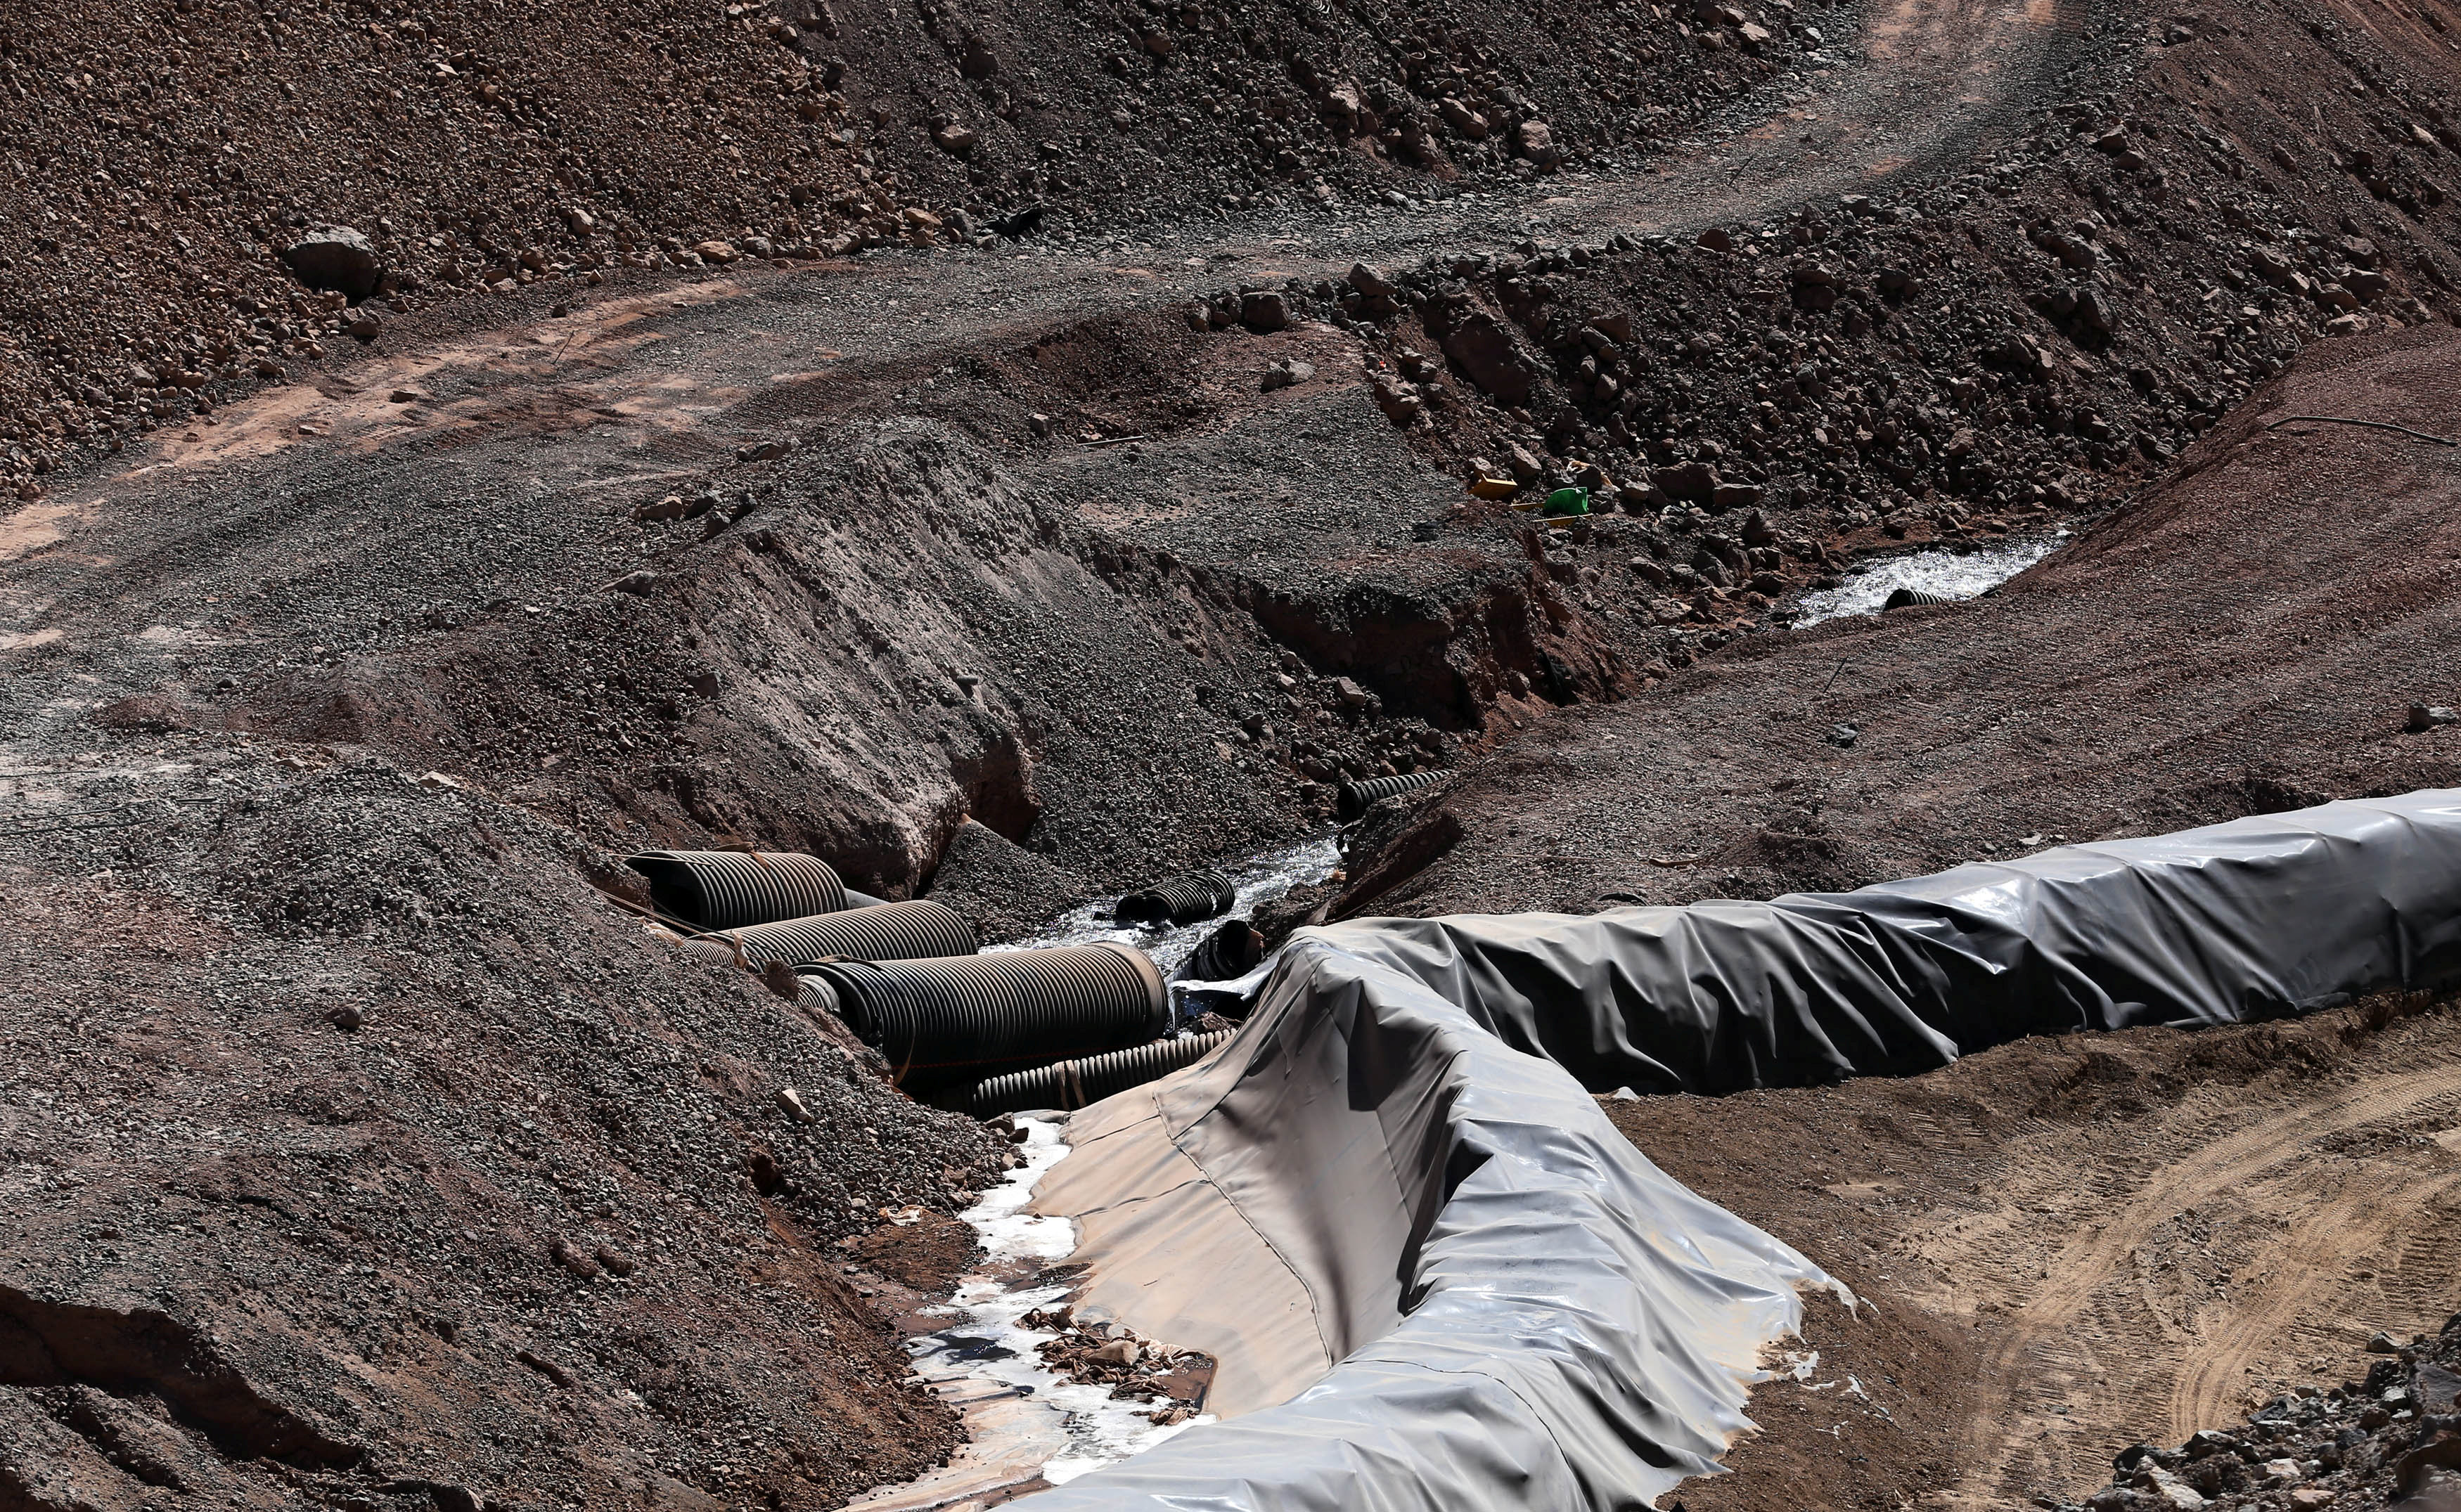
<box><xmin>1036</xmin><ymin>791</ymin><xmax>2461</xmax><ymax>1512</ymax></box>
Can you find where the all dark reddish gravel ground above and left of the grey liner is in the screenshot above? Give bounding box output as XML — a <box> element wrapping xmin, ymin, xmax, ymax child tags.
<box><xmin>14</xmin><ymin>0</ymin><xmax>2461</xmax><ymax>1510</ymax></box>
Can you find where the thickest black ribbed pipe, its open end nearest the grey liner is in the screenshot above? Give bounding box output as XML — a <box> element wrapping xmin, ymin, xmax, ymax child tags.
<box><xmin>797</xmin><ymin>939</ymin><xmax>1171</xmax><ymax>1092</ymax></box>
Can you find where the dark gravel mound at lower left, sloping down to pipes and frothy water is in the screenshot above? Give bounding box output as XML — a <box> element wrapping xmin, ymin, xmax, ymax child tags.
<box><xmin>0</xmin><ymin>747</ymin><xmax>1007</xmax><ymax>1510</ymax></box>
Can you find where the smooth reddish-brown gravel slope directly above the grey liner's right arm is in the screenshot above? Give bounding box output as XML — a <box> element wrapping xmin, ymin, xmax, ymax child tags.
<box><xmin>1342</xmin><ymin>327</ymin><xmax>2461</xmax><ymax>915</ymax></box>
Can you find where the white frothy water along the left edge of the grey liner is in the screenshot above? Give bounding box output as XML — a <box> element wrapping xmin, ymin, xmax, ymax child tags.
<box><xmin>906</xmin><ymin>1118</ymin><xmax>1214</xmax><ymax>1485</ymax></box>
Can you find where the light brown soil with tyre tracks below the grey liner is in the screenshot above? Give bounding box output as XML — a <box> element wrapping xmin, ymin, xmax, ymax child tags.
<box><xmin>1605</xmin><ymin>998</ymin><xmax>2461</xmax><ymax>1512</ymax></box>
